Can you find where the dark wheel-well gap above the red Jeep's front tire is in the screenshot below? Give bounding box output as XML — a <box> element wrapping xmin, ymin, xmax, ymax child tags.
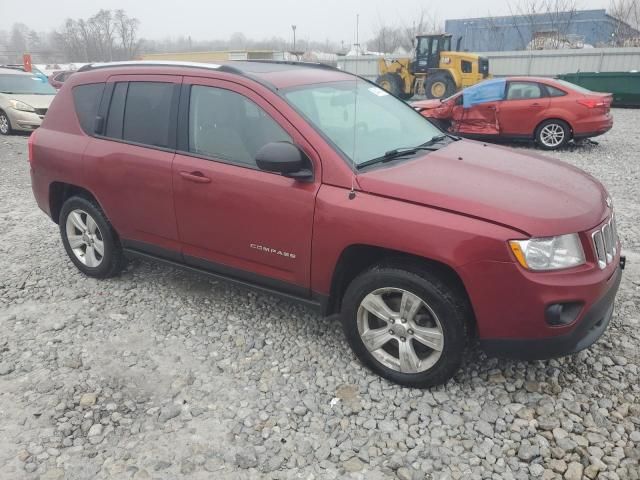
<box><xmin>326</xmin><ymin>244</ymin><xmax>476</xmax><ymax>333</ymax></box>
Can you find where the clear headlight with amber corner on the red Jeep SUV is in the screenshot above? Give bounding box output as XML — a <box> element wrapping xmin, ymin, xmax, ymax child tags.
<box><xmin>509</xmin><ymin>233</ymin><xmax>585</xmax><ymax>271</ymax></box>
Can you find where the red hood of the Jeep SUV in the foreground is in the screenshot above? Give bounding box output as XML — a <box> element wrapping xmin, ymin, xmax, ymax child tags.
<box><xmin>358</xmin><ymin>140</ymin><xmax>609</xmax><ymax>237</ymax></box>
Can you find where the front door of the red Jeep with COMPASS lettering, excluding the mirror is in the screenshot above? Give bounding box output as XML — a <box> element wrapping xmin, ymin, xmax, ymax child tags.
<box><xmin>173</xmin><ymin>77</ymin><xmax>321</xmax><ymax>295</ymax></box>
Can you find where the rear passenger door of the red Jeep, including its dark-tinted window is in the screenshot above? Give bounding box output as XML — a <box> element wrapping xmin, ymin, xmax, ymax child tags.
<box><xmin>85</xmin><ymin>75</ymin><xmax>182</xmax><ymax>253</ymax></box>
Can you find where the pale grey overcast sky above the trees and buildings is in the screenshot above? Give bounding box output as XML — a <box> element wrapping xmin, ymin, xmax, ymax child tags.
<box><xmin>0</xmin><ymin>0</ymin><xmax>609</xmax><ymax>43</ymax></box>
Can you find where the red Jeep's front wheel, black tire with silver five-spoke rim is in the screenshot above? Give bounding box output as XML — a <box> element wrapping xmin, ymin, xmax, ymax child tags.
<box><xmin>342</xmin><ymin>266</ymin><xmax>468</xmax><ymax>388</ymax></box>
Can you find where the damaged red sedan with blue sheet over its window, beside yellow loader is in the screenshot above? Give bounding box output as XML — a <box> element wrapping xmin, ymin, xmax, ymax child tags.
<box><xmin>412</xmin><ymin>77</ymin><xmax>613</xmax><ymax>150</ymax></box>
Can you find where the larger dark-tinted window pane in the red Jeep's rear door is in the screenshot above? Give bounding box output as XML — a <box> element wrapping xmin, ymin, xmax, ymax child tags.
<box><xmin>122</xmin><ymin>82</ymin><xmax>174</xmax><ymax>147</ymax></box>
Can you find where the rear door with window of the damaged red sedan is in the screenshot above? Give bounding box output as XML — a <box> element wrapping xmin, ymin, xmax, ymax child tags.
<box><xmin>498</xmin><ymin>81</ymin><xmax>549</xmax><ymax>137</ymax></box>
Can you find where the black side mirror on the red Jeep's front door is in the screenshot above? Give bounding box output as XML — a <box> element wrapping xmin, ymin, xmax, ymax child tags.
<box><xmin>256</xmin><ymin>142</ymin><xmax>313</xmax><ymax>181</ymax></box>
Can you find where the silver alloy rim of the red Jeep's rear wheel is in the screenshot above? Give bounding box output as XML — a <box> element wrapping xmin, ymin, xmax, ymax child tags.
<box><xmin>65</xmin><ymin>209</ymin><xmax>104</xmax><ymax>268</ymax></box>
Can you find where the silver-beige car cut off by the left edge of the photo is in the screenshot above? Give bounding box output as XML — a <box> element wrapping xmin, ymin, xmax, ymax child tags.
<box><xmin>0</xmin><ymin>68</ymin><xmax>56</xmax><ymax>135</ymax></box>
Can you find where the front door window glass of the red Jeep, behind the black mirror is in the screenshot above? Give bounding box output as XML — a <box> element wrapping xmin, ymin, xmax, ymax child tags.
<box><xmin>189</xmin><ymin>85</ymin><xmax>293</xmax><ymax>168</ymax></box>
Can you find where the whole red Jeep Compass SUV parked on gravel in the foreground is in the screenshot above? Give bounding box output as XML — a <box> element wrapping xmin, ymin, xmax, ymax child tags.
<box><xmin>29</xmin><ymin>62</ymin><xmax>624</xmax><ymax>387</ymax></box>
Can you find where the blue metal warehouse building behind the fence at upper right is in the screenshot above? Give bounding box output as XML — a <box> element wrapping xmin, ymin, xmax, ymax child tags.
<box><xmin>445</xmin><ymin>10</ymin><xmax>630</xmax><ymax>52</ymax></box>
